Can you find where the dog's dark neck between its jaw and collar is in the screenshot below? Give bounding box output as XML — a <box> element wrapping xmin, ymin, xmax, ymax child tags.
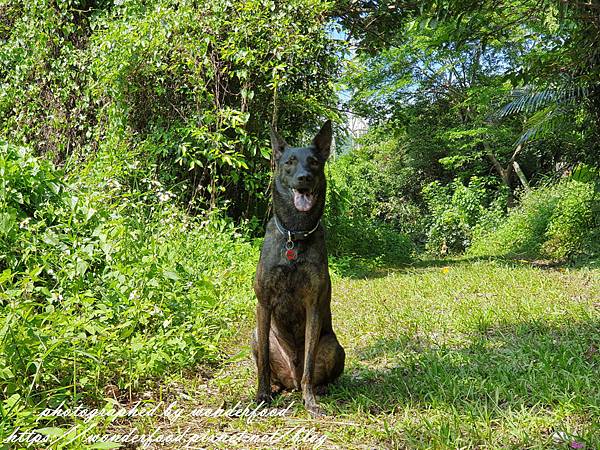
<box><xmin>273</xmin><ymin>180</ymin><xmax>326</xmax><ymax>231</ymax></box>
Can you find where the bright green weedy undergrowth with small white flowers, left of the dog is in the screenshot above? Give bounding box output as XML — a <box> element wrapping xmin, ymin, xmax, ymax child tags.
<box><xmin>0</xmin><ymin>143</ymin><xmax>257</xmax><ymax>438</ymax></box>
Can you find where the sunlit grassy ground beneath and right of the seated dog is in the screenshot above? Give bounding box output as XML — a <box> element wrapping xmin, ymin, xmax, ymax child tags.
<box><xmin>99</xmin><ymin>259</ymin><xmax>600</xmax><ymax>449</ymax></box>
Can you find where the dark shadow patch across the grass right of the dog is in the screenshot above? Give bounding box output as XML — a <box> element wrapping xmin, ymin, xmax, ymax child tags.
<box><xmin>324</xmin><ymin>320</ymin><xmax>600</xmax><ymax>416</ymax></box>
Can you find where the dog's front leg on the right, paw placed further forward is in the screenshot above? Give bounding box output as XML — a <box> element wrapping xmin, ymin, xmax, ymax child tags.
<box><xmin>302</xmin><ymin>304</ymin><xmax>323</xmax><ymax>417</ymax></box>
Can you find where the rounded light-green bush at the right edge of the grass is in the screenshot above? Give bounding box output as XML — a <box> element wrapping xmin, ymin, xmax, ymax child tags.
<box><xmin>469</xmin><ymin>179</ymin><xmax>600</xmax><ymax>259</ymax></box>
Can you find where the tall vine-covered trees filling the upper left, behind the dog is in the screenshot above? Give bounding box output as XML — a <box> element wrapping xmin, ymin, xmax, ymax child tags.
<box><xmin>0</xmin><ymin>0</ymin><xmax>341</xmax><ymax>219</ymax></box>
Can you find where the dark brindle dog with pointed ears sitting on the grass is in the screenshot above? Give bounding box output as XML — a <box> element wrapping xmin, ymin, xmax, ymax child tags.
<box><xmin>252</xmin><ymin>121</ymin><xmax>345</xmax><ymax>416</ymax></box>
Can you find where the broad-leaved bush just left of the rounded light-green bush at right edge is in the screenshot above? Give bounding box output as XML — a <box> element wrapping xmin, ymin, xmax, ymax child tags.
<box><xmin>423</xmin><ymin>177</ymin><xmax>505</xmax><ymax>253</ymax></box>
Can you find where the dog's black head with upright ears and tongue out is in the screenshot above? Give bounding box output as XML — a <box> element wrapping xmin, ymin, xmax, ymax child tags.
<box><xmin>271</xmin><ymin>120</ymin><xmax>332</xmax><ymax>213</ymax></box>
